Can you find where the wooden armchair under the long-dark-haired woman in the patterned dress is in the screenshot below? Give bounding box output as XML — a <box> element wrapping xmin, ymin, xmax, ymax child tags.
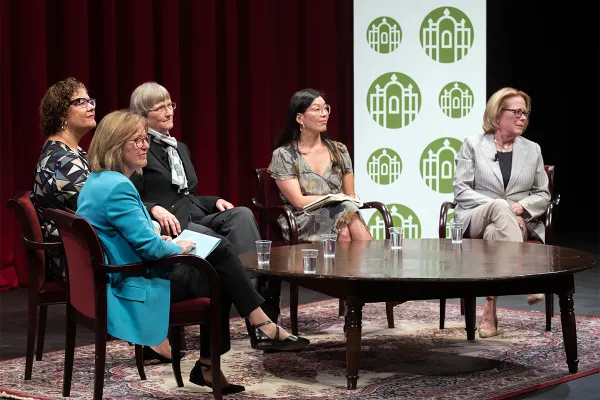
<box><xmin>252</xmin><ymin>168</ymin><xmax>399</xmax><ymax>335</ymax></box>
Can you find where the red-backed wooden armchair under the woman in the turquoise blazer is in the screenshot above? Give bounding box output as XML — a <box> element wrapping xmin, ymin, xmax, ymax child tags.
<box><xmin>44</xmin><ymin>209</ymin><xmax>222</xmax><ymax>400</ymax></box>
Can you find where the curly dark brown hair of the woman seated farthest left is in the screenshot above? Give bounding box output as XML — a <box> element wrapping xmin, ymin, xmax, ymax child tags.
<box><xmin>40</xmin><ymin>77</ymin><xmax>87</xmax><ymax>137</ymax></box>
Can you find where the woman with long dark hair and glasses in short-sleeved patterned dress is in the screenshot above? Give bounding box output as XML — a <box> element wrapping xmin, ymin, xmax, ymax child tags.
<box><xmin>269</xmin><ymin>89</ymin><xmax>372</xmax><ymax>242</ymax></box>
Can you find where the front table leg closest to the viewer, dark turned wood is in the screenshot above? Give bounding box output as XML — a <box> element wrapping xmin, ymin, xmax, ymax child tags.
<box><xmin>346</xmin><ymin>299</ymin><xmax>364</xmax><ymax>390</ymax></box>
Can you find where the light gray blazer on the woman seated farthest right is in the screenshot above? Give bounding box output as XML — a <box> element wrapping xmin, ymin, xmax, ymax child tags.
<box><xmin>454</xmin><ymin>133</ymin><xmax>550</xmax><ymax>241</ymax></box>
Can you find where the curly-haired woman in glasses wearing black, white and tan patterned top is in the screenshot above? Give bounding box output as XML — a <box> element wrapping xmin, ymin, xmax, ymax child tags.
<box><xmin>31</xmin><ymin>78</ymin><xmax>96</xmax><ymax>280</ymax></box>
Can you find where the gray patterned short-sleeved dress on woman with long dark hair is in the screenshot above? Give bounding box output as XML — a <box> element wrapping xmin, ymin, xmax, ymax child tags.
<box><xmin>268</xmin><ymin>140</ymin><xmax>366</xmax><ymax>242</ymax></box>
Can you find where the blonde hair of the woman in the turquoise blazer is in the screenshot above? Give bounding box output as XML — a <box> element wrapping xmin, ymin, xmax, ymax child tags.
<box><xmin>88</xmin><ymin>110</ymin><xmax>148</xmax><ymax>173</ymax></box>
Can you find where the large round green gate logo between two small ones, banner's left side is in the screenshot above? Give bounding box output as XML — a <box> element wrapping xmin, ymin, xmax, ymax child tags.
<box><xmin>367</xmin><ymin>72</ymin><xmax>421</xmax><ymax>129</ymax></box>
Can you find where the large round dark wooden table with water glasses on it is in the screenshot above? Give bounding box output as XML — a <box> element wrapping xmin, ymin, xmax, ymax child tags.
<box><xmin>240</xmin><ymin>239</ymin><xmax>598</xmax><ymax>389</ymax></box>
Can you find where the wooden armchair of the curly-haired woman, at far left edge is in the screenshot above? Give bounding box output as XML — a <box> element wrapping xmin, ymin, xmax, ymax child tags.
<box><xmin>6</xmin><ymin>191</ymin><xmax>67</xmax><ymax>380</ymax></box>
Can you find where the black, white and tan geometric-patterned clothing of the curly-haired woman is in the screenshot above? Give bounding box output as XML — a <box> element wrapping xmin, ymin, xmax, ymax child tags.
<box><xmin>31</xmin><ymin>140</ymin><xmax>90</xmax><ymax>280</ymax></box>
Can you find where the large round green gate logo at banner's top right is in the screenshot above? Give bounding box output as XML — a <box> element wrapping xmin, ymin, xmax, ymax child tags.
<box><xmin>419</xmin><ymin>7</ymin><xmax>474</xmax><ymax>63</ymax></box>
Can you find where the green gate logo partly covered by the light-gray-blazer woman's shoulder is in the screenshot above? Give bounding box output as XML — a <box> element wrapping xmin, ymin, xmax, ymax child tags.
<box><xmin>419</xmin><ymin>137</ymin><xmax>462</xmax><ymax>193</ymax></box>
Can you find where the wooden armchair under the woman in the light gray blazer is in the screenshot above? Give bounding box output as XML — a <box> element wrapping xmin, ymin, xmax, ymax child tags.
<box><xmin>438</xmin><ymin>165</ymin><xmax>560</xmax><ymax>331</ymax></box>
